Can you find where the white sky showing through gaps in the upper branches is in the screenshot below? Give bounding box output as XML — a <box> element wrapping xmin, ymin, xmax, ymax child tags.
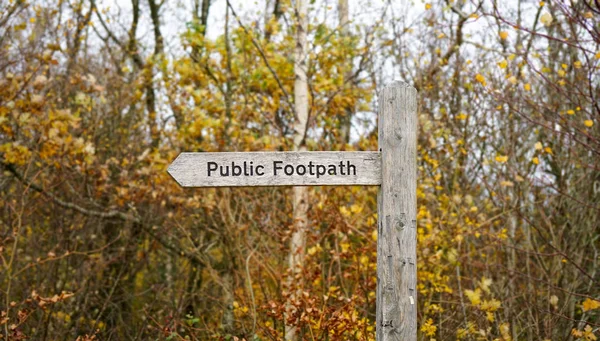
<box><xmin>91</xmin><ymin>0</ymin><xmax>564</xmax><ymax>140</ymax></box>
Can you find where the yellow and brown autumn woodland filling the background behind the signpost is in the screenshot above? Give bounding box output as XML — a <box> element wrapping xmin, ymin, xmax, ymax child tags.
<box><xmin>0</xmin><ymin>0</ymin><xmax>600</xmax><ymax>341</ymax></box>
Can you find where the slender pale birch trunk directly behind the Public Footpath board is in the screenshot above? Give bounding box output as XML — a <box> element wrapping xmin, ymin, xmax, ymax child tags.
<box><xmin>285</xmin><ymin>0</ymin><xmax>308</xmax><ymax>340</ymax></box>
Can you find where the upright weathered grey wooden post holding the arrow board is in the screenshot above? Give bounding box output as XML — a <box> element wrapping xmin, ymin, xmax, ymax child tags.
<box><xmin>376</xmin><ymin>82</ymin><xmax>417</xmax><ymax>341</ymax></box>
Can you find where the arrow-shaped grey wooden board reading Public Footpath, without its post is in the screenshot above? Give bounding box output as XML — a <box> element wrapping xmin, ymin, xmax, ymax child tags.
<box><xmin>167</xmin><ymin>152</ymin><xmax>381</xmax><ymax>187</ymax></box>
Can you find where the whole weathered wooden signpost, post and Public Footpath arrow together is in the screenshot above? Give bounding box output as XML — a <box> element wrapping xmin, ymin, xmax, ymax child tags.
<box><xmin>168</xmin><ymin>82</ymin><xmax>417</xmax><ymax>341</ymax></box>
